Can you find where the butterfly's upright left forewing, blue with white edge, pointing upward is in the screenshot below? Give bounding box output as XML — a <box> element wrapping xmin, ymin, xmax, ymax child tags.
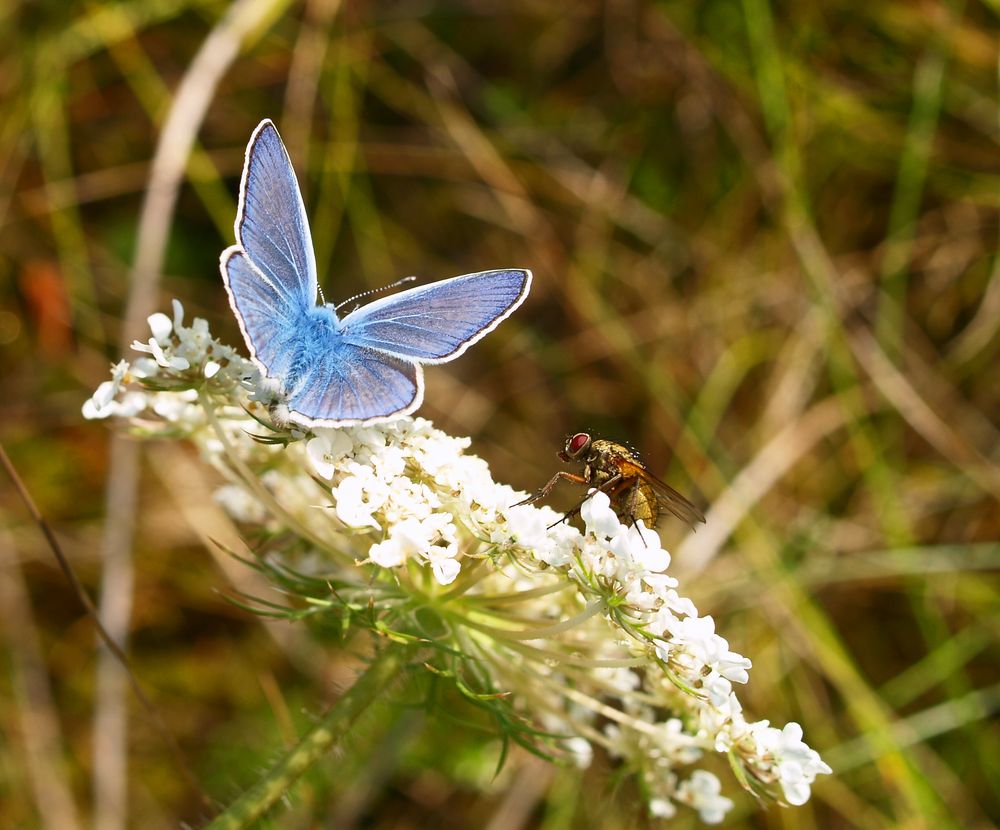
<box><xmin>236</xmin><ymin>119</ymin><xmax>316</xmax><ymax>316</ymax></box>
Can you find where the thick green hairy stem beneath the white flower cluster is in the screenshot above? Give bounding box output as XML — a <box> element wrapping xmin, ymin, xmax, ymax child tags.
<box><xmin>205</xmin><ymin>644</ymin><xmax>410</xmax><ymax>830</ymax></box>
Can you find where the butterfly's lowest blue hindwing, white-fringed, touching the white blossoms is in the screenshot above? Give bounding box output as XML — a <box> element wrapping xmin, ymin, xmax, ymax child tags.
<box><xmin>287</xmin><ymin>332</ymin><xmax>424</xmax><ymax>427</ymax></box>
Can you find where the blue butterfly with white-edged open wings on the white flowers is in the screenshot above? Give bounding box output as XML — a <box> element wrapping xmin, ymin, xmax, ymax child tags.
<box><xmin>220</xmin><ymin>119</ymin><xmax>531</xmax><ymax>427</ymax></box>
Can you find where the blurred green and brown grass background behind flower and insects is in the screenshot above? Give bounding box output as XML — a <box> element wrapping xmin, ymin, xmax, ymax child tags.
<box><xmin>0</xmin><ymin>0</ymin><xmax>1000</xmax><ymax>830</ymax></box>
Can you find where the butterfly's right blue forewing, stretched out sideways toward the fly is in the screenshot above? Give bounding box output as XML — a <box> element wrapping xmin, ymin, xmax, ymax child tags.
<box><xmin>340</xmin><ymin>269</ymin><xmax>531</xmax><ymax>363</ymax></box>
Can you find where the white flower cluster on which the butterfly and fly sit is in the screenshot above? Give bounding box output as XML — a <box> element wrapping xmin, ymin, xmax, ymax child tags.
<box><xmin>84</xmin><ymin>302</ymin><xmax>831</xmax><ymax>823</ymax></box>
